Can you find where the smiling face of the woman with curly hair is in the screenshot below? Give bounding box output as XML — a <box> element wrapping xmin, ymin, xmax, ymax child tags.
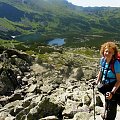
<box><xmin>104</xmin><ymin>46</ymin><xmax>114</xmax><ymax>59</ymax></box>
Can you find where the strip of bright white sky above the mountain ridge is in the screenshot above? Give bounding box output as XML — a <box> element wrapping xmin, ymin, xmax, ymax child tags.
<box><xmin>67</xmin><ymin>0</ymin><xmax>120</xmax><ymax>7</ymax></box>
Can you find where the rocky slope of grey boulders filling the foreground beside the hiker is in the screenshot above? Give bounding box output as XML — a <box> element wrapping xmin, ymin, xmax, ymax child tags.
<box><xmin>0</xmin><ymin>46</ymin><xmax>120</xmax><ymax>120</ymax></box>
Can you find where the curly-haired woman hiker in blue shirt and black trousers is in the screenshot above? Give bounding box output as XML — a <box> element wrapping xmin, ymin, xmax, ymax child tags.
<box><xmin>96</xmin><ymin>42</ymin><xmax>120</xmax><ymax>120</ymax></box>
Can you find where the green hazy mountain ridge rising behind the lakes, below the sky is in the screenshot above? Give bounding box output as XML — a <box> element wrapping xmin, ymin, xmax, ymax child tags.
<box><xmin>0</xmin><ymin>0</ymin><xmax>120</xmax><ymax>47</ymax></box>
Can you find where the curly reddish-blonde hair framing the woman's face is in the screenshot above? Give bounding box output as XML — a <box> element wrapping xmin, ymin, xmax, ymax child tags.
<box><xmin>100</xmin><ymin>42</ymin><xmax>118</xmax><ymax>58</ymax></box>
